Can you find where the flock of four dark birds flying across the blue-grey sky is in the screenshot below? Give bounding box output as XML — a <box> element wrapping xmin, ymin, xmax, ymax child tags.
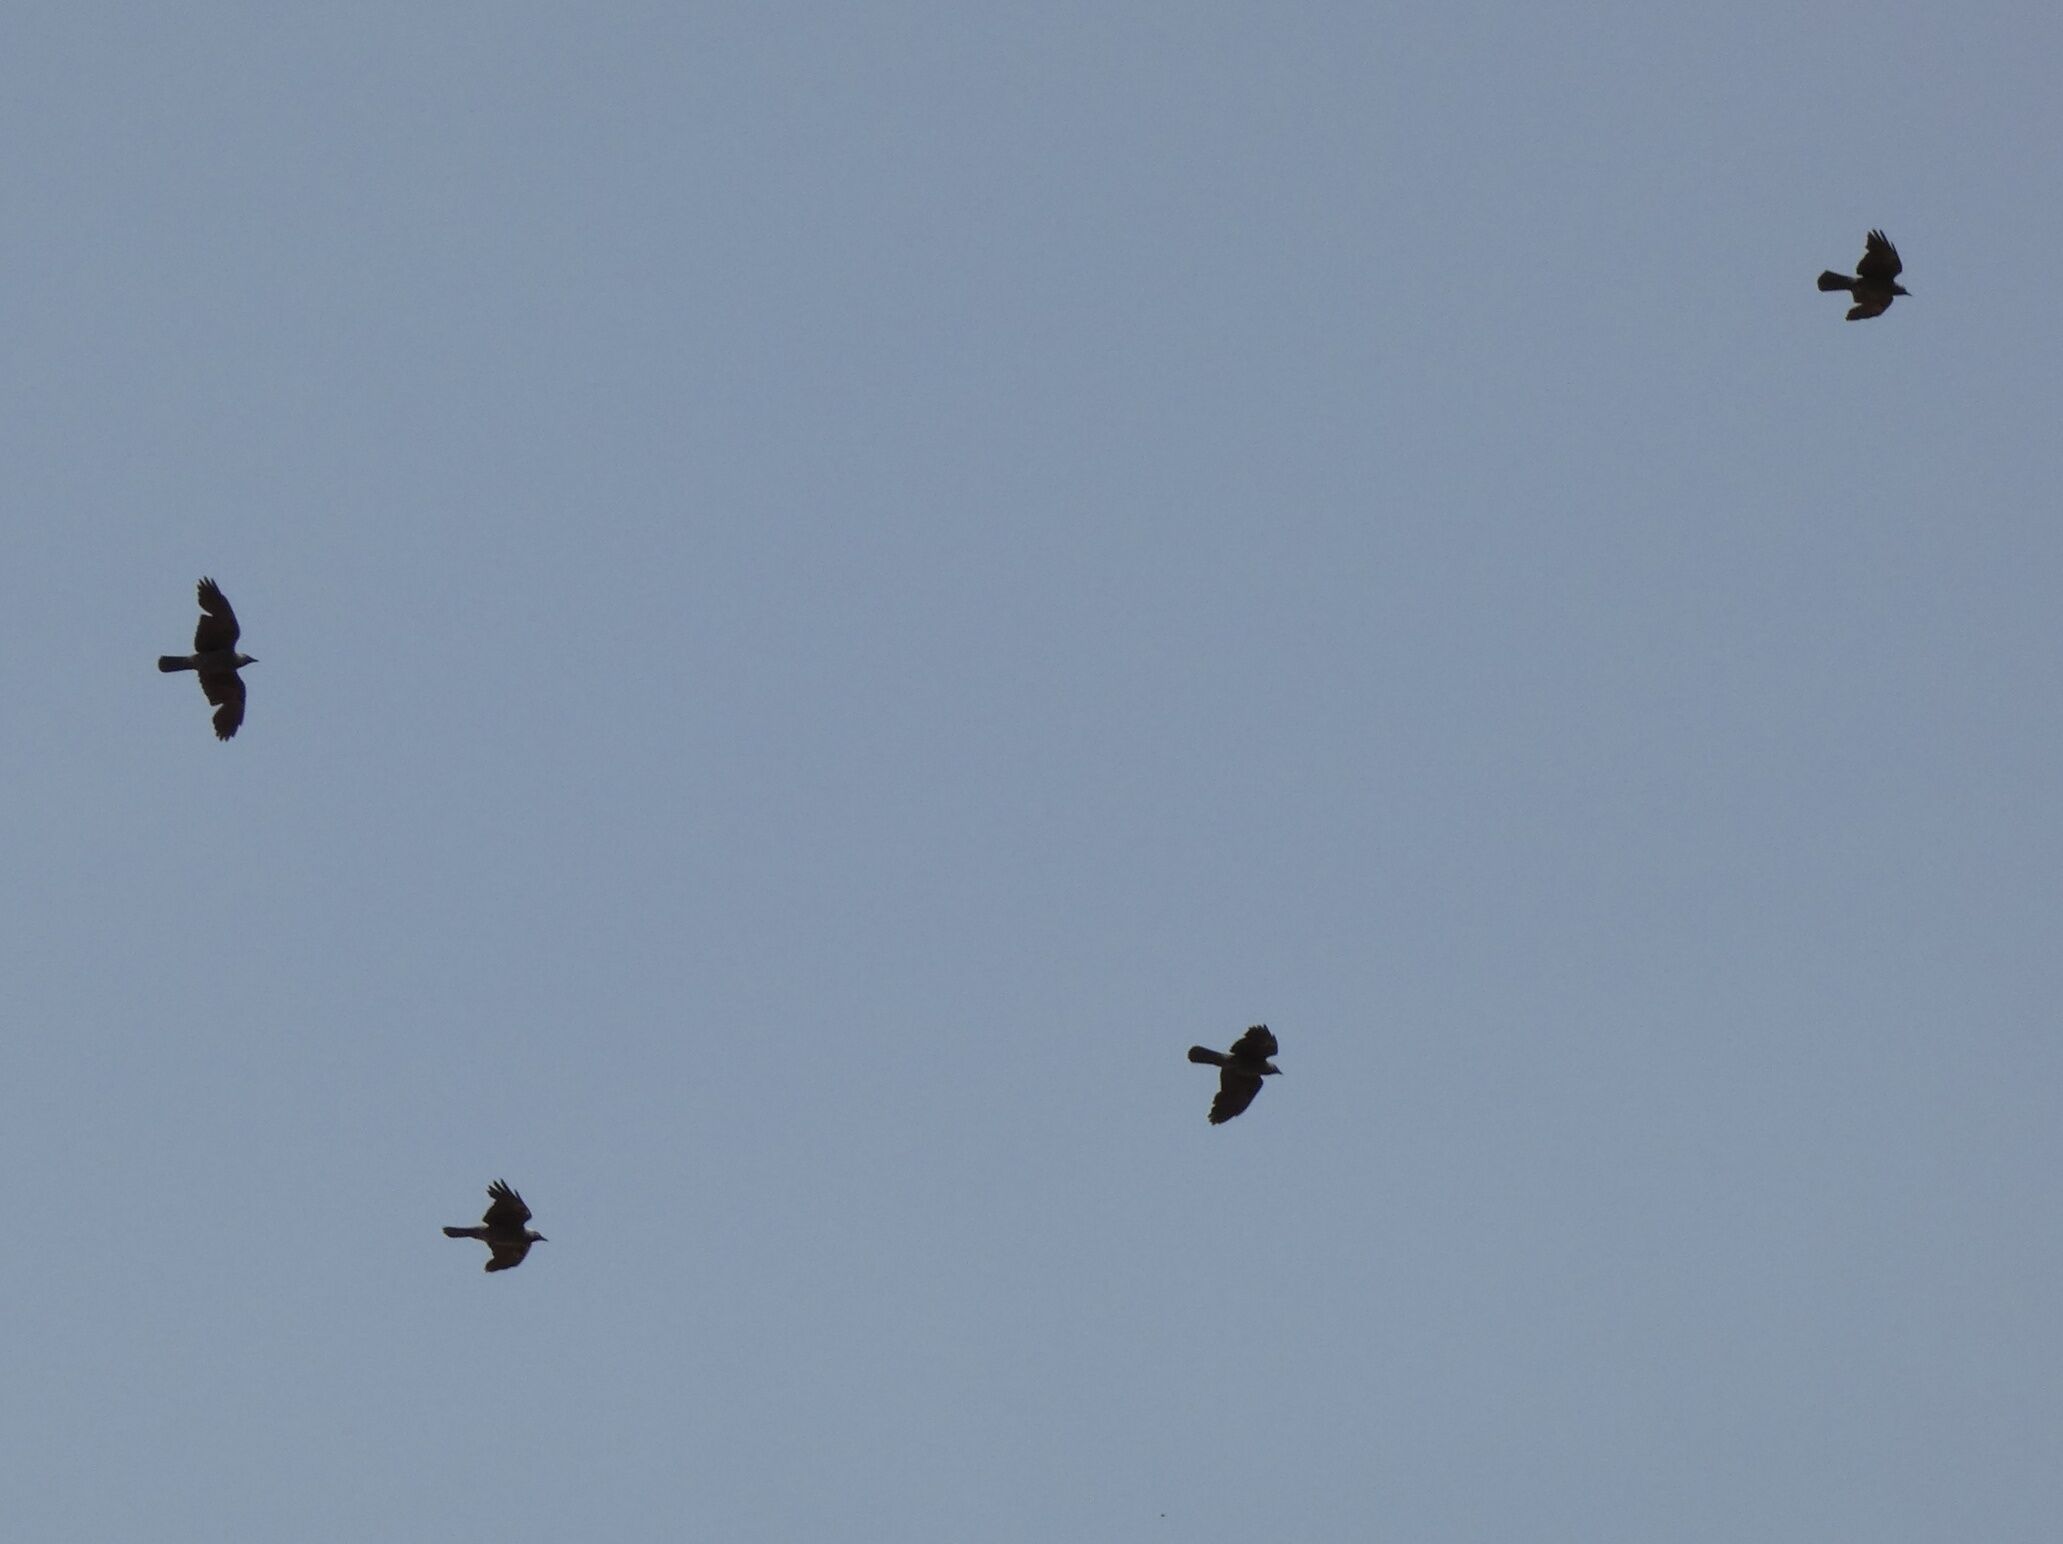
<box><xmin>157</xmin><ymin>231</ymin><xmax>1910</xmax><ymax>1272</ymax></box>
